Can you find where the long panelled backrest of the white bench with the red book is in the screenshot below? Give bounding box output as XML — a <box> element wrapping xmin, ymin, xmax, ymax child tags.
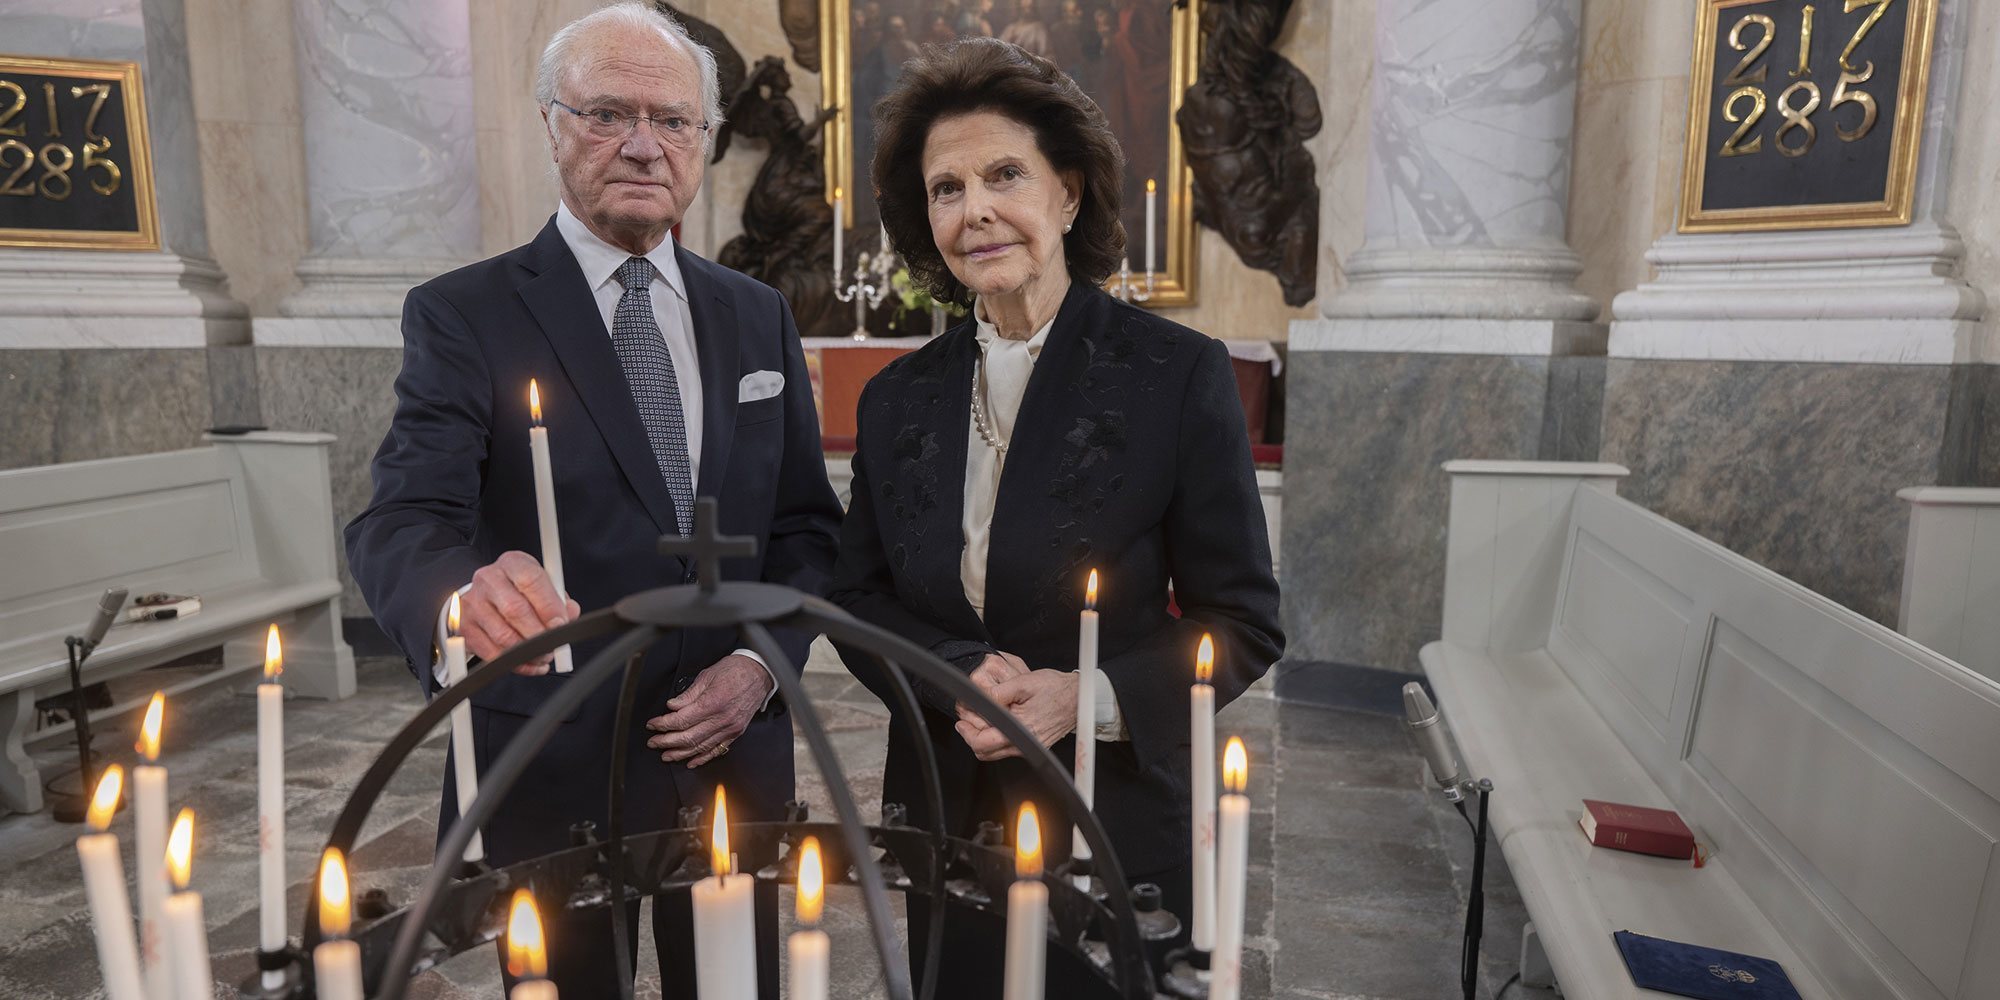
<box><xmin>1546</xmin><ymin>488</ymin><xmax>2000</xmax><ymax>1000</ymax></box>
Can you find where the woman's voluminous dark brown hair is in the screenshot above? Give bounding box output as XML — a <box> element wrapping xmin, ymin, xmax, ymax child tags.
<box><xmin>870</xmin><ymin>38</ymin><xmax>1126</xmax><ymax>304</ymax></box>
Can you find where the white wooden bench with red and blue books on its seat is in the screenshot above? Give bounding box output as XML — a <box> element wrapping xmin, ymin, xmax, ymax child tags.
<box><xmin>1422</xmin><ymin>462</ymin><xmax>2000</xmax><ymax>1000</ymax></box>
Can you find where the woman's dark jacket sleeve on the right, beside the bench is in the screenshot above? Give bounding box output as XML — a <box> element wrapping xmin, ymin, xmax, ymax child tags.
<box><xmin>1098</xmin><ymin>340</ymin><xmax>1284</xmax><ymax>766</ymax></box>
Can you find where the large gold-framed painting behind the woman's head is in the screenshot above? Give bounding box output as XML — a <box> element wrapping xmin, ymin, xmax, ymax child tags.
<box><xmin>820</xmin><ymin>0</ymin><xmax>1202</xmax><ymax>306</ymax></box>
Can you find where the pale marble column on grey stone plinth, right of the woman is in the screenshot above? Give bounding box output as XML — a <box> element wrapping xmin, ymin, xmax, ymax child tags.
<box><xmin>1284</xmin><ymin>0</ymin><xmax>1604</xmax><ymax>670</ymax></box>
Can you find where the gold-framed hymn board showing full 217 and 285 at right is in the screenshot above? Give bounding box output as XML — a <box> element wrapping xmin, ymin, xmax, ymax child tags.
<box><xmin>1680</xmin><ymin>0</ymin><xmax>1938</xmax><ymax>232</ymax></box>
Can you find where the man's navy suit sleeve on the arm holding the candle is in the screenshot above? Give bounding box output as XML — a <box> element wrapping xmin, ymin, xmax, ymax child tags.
<box><xmin>346</xmin><ymin>286</ymin><xmax>492</xmax><ymax>692</ymax></box>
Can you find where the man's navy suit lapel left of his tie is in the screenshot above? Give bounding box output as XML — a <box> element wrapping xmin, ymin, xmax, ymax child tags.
<box><xmin>520</xmin><ymin>218</ymin><xmax>684</xmax><ymax>534</ymax></box>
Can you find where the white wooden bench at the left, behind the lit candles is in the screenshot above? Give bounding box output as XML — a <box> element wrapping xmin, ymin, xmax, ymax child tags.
<box><xmin>0</xmin><ymin>432</ymin><xmax>354</xmax><ymax>812</ymax></box>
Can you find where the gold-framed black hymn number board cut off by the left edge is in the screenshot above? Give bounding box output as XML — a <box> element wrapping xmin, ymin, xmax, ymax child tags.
<box><xmin>0</xmin><ymin>56</ymin><xmax>160</xmax><ymax>250</ymax></box>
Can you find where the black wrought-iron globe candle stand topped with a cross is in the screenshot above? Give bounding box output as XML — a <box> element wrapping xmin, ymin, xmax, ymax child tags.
<box><xmin>240</xmin><ymin>498</ymin><xmax>1206</xmax><ymax>1000</ymax></box>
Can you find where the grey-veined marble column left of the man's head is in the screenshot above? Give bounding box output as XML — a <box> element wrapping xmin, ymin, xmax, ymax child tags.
<box><xmin>256</xmin><ymin>0</ymin><xmax>480</xmax><ymax>346</ymax></box>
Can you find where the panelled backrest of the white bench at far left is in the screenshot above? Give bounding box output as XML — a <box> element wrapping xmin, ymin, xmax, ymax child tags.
<box><xmin>0</xmin><ymin>448</ymin><xmax>260</xmax><ymax>672</ymax></box>
